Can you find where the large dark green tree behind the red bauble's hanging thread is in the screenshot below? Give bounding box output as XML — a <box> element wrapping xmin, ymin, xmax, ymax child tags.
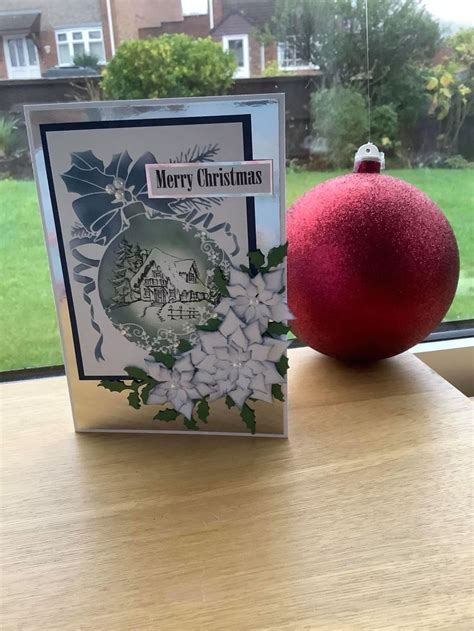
<box><xmin>269</xmin><ymin>0</ymin><xmax>440</xmax><ymax>125</ymax></box>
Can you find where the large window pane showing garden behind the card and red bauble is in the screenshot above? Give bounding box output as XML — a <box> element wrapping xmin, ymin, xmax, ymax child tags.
<box><xmin>0</xmin><ymin>0</ymin><xmax>474</xmax><ymax>371</ymax></box>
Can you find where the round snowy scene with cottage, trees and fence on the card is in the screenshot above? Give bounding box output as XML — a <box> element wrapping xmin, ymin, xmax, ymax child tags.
<box><xmin>102</xmin><ymin>238</ymin><xmax>220</xmax><ymax>345</ymax></box>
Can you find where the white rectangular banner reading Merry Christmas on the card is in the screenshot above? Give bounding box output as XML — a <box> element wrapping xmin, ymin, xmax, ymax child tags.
<box><xmin>145</xmin><ymin>160</ymin><xmax>273</xmax><ymax>198</ymax></box>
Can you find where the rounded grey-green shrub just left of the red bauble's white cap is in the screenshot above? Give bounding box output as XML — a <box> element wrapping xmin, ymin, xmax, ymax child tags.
<box><xmin>311</xmin><ymin>87</ymin><xmax>367</xmax><ymax>168</ymax></box>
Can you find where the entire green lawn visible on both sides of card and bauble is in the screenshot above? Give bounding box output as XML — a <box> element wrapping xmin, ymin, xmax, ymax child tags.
<box><xmin>0</xmin><ymin>169</ymin><xmax>474</xmax><ymax>371</ymax></box>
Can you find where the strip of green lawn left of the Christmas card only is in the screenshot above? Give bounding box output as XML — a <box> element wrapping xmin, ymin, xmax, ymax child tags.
<box><xmin>0</xmin><ymin>180</ymin><xmax>63</xmax><ymax>371</ymax></box>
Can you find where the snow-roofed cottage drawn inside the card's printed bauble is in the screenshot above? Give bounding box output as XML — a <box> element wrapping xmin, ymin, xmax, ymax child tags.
<box><xmin>130</xmin><ymin>248</ymin><xmax>209</xmax><ymax>304</ymax></box>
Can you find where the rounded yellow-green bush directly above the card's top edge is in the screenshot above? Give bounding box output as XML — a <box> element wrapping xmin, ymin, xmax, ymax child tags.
<box><xmin>103</xmin><ymin>33</ymin><xmax>236</xmax><ymax>99</ymax></box>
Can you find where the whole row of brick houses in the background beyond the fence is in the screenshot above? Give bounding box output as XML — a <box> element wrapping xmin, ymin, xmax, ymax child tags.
<box><xmin>0</xmin><ymin>0</ymin><xmax>311</xmax><ymax>80</ymax></box>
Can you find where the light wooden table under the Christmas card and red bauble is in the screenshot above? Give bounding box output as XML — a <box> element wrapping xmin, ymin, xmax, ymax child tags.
<box><xmin>1</xmin><ymin>349</ymin><xmax>473</xmax><ymax>631</ymax></box>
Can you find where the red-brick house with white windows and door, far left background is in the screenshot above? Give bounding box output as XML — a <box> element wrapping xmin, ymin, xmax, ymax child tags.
<box><xmin>0</xmin><ymin>0</ymin><xmax>112</xmax><ymax>79</ymax></box>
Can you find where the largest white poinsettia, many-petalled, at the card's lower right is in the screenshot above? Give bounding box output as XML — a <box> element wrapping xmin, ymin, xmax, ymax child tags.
<box><xmin>189</xmin><ymin>320</ymin><xmax>288</xmax><ymax>408</ymax></box>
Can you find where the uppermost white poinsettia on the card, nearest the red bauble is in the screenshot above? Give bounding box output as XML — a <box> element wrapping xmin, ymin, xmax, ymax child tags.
<box><xmin>215</xmin><ymin>265</ymin><xmax>293</xmax><ymax>333</ymax></box>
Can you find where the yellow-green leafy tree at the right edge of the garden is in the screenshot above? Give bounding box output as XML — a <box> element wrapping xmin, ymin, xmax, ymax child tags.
<box><xmin>426</xmin><ymin>28</ymin><xmax>474</xmax><ymax>153</ymax></box>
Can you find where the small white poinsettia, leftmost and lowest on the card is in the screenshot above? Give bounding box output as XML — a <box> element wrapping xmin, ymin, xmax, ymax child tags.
<box><xmin>145</xmin><ymin>353</ymin><xmax>211</xmax><ymax>418</ymax></box>
